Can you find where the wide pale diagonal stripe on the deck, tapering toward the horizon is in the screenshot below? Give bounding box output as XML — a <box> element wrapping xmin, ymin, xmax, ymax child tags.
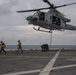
<box><xmin>39</xmin><ymin>49</ymin><xmax>62</xmax><ymax>75</ymax></box>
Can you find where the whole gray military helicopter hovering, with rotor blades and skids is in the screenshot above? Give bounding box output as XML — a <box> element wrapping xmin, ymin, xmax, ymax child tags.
<box><xmin>17</xmin><ymin>0</ymin><xmax>76</xmax><ymax>32</ymax></box>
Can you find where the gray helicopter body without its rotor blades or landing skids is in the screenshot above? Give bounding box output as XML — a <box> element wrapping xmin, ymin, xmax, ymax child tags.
<box><xmin>26</xmin><ymin>9</ymin><xmax>76</xmax><ymax>30</ymax></box>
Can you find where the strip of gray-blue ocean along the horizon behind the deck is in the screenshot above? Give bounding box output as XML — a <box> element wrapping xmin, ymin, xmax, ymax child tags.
<box><xmin>6</xmin><ymin>45</ymin><xmax>76</xmax><ymax>50</ymax></box>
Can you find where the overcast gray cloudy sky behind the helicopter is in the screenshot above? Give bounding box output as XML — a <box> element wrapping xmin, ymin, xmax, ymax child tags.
<box><xmin>0</xmin><ymin>0</ymin><xmax>76</xmax><ymax>45</ymax></box>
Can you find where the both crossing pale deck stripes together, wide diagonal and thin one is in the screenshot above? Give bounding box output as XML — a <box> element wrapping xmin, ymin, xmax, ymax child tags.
<box><xmin>3</xmin><ymin>49</ymin><xmax>76</xmax><ymax>75</ymax></box>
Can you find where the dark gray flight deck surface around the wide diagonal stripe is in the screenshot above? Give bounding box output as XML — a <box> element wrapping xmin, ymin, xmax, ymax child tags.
<box><xmin>0</xmin><ymin>50</ymin><xmax>76</xmax><ymax>75</ymax></box>
